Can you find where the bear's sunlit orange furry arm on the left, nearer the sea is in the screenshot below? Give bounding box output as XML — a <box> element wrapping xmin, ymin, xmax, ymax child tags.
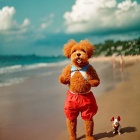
<box><xmin>59</xmin><ymin>64</ymin><xmax>71</xmax><ymax>85</ymax></box>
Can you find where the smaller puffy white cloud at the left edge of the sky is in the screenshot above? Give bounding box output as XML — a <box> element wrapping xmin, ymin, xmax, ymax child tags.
<box><xmin>0</xmin><ymin>6</ymin><xmax>30</xmax><ymax>33</ymax></box>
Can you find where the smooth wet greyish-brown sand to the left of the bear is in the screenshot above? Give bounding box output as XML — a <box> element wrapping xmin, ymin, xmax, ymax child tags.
<box><xmin>0</xmin><ymin>73</ymin><xmax>66</xmax><ymax>140</ymax></box>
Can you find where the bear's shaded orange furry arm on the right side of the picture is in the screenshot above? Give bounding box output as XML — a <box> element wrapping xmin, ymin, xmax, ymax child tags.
<box><xmin>87</xmin><ymin>66</ymin><xmax>100</xmax><ymax>87</ymax></box>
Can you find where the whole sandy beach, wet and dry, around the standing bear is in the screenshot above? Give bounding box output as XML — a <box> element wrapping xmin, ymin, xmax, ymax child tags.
<box><xmin>0</xmin><ymin>58</ymin><xmax>140</xmax><ymax>140</ymax></box>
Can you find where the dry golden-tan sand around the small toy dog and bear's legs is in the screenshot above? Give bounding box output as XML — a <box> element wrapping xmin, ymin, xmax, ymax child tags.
<box><xmin>56</xmin><ymin>59</ymin><xmax>140</xmax><ymax>140</ymax></box>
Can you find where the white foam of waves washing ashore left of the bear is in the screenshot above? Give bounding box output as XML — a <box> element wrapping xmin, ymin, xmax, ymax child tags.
<box><xmin>0</xmin><ymin>61</ymin><xmax>69</xmax><ymax>87</ymax></box>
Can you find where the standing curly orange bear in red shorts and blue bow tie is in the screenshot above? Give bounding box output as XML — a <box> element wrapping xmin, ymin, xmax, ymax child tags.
<box><xmin>59</xmin><ymin>40</ymin><xmax>100</xmax><ymax>140</ymax></box>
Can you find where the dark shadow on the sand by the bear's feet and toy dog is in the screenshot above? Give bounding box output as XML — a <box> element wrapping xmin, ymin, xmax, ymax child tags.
<box><xmin>77</xmin><ymin>127</ymin><xmax>137</xmax><ymax>140</ymax></box>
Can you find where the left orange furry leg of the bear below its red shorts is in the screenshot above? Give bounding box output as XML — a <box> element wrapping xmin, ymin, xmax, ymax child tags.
<box><xmin>67</xmin><ymin>119</ymin><xmax>77</xmax><ymax>140</ymax></box>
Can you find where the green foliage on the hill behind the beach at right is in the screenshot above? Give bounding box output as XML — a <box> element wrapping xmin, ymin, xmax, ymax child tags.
<box><xmin>94</xmin><ymin>37</ymin><xmax>140</xmax><ymax>56</ymax></box>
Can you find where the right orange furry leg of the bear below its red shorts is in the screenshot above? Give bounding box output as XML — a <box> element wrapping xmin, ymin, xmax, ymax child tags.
<box><xmin>85</xmin><ymin>120</ymin><xmax>95</xmax><ymax>140</ymax></box>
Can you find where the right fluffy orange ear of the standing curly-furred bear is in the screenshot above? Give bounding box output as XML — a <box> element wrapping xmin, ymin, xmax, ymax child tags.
<box><xmin>80</xmin><ymin>40</ymin><xmax>94</xmax><ymax>58</ymax></box>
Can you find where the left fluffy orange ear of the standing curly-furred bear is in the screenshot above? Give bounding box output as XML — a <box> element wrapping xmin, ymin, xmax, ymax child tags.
<box><xmin>63</xmin><ymin>40</ymin><xmax>77</xmax><ymax>58</ymax></box>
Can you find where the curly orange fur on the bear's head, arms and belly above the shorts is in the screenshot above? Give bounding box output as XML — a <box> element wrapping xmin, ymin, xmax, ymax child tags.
<box><xmin>59</xmin><ymin>40</ymin><xmax>100</xmax><ymax>94</ymax></box>
